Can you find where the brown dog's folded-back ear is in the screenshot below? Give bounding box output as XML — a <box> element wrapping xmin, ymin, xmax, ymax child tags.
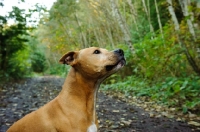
<box><xmin>59</xmin><ymin>51</ymin><xmax>78</xmax><ymax>66</ymax></box>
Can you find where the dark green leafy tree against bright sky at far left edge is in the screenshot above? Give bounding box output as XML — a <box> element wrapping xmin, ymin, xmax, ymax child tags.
<box><xmin>0</xmin><ymin>7</ymin><xmax>28</xmax><ymax>72</ymax></box>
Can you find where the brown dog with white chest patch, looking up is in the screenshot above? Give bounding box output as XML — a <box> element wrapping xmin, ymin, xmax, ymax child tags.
<box><xmin>7</xmin><ymin>47</ymin><xmax>125</xmax><ymax>132</ymax></box>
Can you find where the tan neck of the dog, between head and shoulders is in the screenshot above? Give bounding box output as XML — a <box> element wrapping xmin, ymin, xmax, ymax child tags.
<box><xmin>60</xmin><ymin>67</ymin><xmax>101</xmax><ymax>123</ymax></box>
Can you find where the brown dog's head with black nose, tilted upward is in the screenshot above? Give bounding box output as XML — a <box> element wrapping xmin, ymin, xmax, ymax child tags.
<box><xmin>59</xmin><ymin>47</ymin><xmax>126</xmax><ymax>79</ymax></box>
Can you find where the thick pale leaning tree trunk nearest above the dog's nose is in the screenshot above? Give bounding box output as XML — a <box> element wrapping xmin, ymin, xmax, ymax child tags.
<box><xmin>110</xmin><ymin>0</ymin><xmax>134</xmax><ymax>54</ymax></box>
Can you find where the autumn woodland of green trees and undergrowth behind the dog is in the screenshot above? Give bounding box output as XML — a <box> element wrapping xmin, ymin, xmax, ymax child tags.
<box><xmin>0</xmin><ymin>0</ymin><xmax>200</xmax><ymax>121</ymax></box>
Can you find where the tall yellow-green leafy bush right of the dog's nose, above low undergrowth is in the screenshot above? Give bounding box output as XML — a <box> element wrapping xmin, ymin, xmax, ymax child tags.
<box><xmin>131</xmin><ymin>25</ymin><xmax>198</xmax><ymax>80</ymax></box>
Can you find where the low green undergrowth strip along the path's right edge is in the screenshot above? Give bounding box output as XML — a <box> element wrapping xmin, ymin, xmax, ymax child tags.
<box><xmin>102</xmin><ymin>76</ymin><xmax>200</xmax><ymax>114</ymax></box>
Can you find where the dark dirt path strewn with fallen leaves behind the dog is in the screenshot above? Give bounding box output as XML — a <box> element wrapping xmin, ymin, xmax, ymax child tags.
<box><xmin>0</xmin><ymin>77</ymin><xmax>200</xmax><ymax>132</ymax></box>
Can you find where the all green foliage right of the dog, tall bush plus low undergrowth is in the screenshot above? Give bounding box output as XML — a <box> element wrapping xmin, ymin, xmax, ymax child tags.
<box><xmin>103</xmin><ymin>19</ymin><xmax>200</xmax><ymax>113</ymax></box>
